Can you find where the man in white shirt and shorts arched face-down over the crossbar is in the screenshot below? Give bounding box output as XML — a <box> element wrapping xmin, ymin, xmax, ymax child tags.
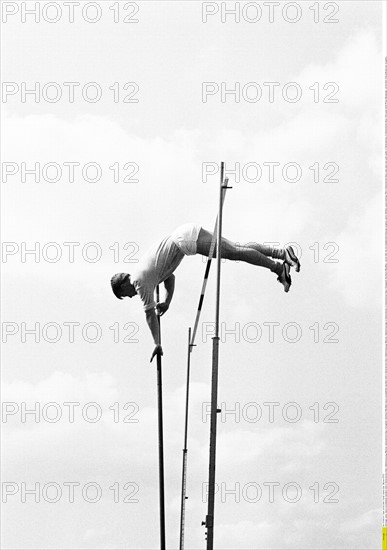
<box><xmin>111</xmin><ymin>223</ymin><xmax>300</xmax><ymax>361</ymax></box>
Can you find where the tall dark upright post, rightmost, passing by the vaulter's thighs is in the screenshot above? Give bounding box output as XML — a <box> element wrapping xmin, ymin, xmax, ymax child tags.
<box><xmin>205</xmin><ymin>162</ymin><xmax>224</xmax><ymax>550</ymax></box>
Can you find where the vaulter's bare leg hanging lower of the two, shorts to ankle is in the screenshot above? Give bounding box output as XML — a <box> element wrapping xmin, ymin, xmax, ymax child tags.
<box><xmin>196</xmin><ymin>228</ymin><xmax>282</xmax><ymax>275</ymax></box>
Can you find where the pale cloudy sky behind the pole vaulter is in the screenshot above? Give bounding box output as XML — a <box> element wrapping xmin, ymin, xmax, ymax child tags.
<box><xmin>2</xmin><ymin>0</ymin><xmax>384</xmax><ymax>549</ymax></box>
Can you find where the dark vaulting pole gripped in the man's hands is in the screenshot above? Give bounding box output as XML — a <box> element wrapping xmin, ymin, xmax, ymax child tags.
<box><xmin>156</xmin><ymin>285</ymin><xmax>165</xmax><ymax>550</ymax></box>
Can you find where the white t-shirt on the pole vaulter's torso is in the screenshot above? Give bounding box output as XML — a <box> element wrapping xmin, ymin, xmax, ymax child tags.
<box><xmin>130</xmin><ymin>235</ymin><xmax>184</xmax><ymax>311</ymax></box>
